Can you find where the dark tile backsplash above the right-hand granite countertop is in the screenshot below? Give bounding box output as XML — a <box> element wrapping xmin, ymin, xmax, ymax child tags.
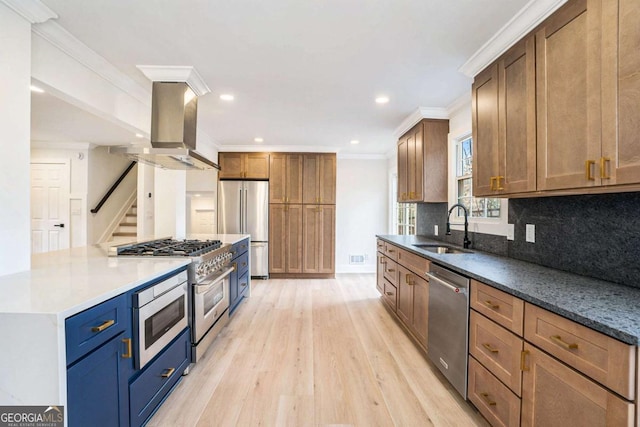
<box><xmin>417</xmin><ymin>193</ymin><xmax>640</xmax><ymax>287</ymax></box>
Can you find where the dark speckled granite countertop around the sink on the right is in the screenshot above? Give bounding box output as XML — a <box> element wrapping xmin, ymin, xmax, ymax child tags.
<box><xmin>377</xmin><ymin>235</ymin><xmax>640</xmax><ymax>345</ymax></box>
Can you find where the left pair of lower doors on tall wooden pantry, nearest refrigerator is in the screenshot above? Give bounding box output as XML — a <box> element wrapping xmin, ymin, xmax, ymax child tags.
<box><xmin>269</xmin><ymin>204</ymin><xmax>302</xmax><ymax>273</ymax></box>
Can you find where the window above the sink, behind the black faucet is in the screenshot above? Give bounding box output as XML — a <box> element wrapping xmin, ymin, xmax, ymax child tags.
<box><xmin>455</xmin><ymin>136</ymin><xmax>501</xmax><ymax>218</ymax></box>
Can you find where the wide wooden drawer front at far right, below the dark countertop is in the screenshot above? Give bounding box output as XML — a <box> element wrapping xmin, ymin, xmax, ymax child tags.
<box><xmin>524</xmin><ymin>303</ymin><xmax>636</xmax><ymax>400</ymax></box>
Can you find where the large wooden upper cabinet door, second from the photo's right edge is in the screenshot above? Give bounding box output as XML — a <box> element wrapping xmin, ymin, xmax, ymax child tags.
<box><xmin>535</xmin><ymin>0</ymin><xmax>603</xmax><ymax>190</ymax></box>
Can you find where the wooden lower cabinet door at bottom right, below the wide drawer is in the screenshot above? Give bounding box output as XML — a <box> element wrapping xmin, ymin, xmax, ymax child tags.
<box><xmin>522</xmin><ymin>343</ymin><xmax>635</xmax><ymax>427</ymax></box>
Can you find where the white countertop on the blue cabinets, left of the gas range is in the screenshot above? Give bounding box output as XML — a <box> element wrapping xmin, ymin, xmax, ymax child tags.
<box><xmin>0</xmin><ymin>243</ymin><xmax>191</xmax><ymax>319</ymax></box>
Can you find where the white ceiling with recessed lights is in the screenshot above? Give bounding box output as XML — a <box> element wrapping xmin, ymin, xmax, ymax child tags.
<box><xmin>32</xmin><ymin>0</ymin><xmax>528</xmax><ymax>155</ymax></box>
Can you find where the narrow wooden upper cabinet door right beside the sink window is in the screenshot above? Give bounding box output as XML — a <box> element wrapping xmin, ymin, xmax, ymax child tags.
<box><xmin>471</xmin><ymin>64</ymin><xmax>498</xmax><ymax>196</ymax></box>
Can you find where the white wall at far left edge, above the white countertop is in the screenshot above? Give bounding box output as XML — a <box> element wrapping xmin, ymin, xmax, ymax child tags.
<box><xmin>0</xmin><ymin>3</ymin><xmax>31</xmax><ymax>275</ymax></box>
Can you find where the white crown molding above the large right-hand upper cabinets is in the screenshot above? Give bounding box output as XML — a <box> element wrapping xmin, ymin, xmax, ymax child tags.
<box><xmin>458</xmin><ymin>0</ymin><xmax>567</xmax><ymax>78</ymax></box>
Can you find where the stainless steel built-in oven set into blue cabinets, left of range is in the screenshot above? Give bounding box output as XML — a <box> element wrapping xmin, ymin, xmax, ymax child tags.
<box><xmin>133</xmin><ymin>270</ymin><xmax>189</xmax><ymax>369</ymax></box>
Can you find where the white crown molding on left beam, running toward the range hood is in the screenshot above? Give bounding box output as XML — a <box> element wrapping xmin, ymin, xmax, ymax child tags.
<box><xmin>31</xmin><ymin>20</ymin><xmax>151</xmax><ymax>107</ymax></box>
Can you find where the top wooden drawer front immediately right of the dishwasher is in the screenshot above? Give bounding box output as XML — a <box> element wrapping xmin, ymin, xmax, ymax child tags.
<box><xmin>470</xmin><ymin>279</ymin><xmax>524</xmax><ymax>336</ymax></box>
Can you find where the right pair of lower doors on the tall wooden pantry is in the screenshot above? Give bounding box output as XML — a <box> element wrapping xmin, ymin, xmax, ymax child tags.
<box><xmin>302</xmin><ymin>205</ymin><xmax>336</xmax><ymax>274</ymax></box>
